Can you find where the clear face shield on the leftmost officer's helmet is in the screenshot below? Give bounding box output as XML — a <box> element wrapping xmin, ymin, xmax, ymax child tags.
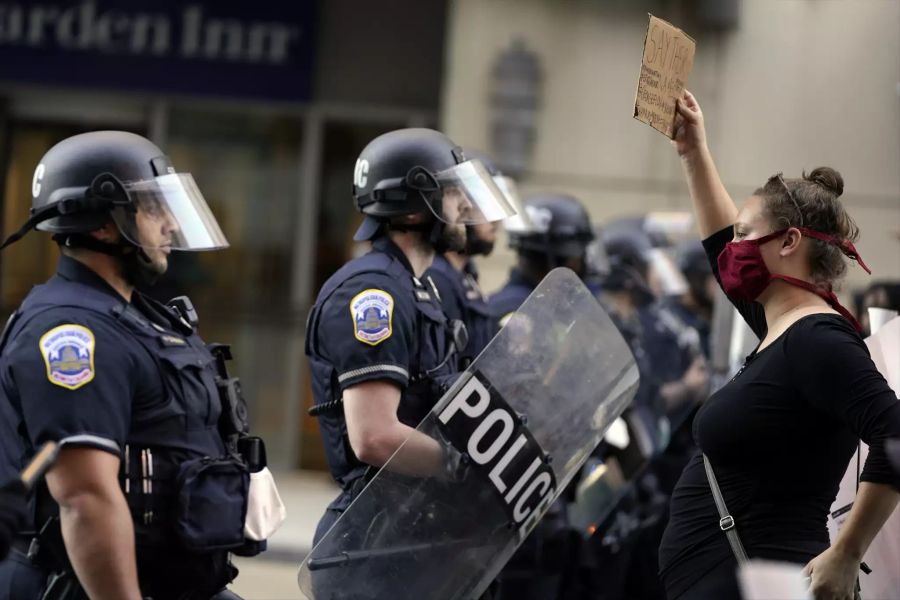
<box><xmin>112</xmin><ymin>173</ymin><xmax>229</xmax><ymax>251</ymax></box>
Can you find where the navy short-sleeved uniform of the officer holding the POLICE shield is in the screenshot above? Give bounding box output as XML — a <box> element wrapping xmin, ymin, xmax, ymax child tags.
<box><xmin>306</xmin><ymin>237</ymin><xmax>457</xmax><ymax>541</ymax></box>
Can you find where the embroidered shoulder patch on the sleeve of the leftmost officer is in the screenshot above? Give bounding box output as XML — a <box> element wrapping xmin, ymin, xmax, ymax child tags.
<box><xmin>39</xmin><ymin>324</ymin><xmax>94</xmax><ymax>390</ymax></box>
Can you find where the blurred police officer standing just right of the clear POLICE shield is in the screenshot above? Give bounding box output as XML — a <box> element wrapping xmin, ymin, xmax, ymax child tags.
<box><xmin>592</xmin><ymin>229</ymin><xmax>709</xmax><ymax>600</ymax></box>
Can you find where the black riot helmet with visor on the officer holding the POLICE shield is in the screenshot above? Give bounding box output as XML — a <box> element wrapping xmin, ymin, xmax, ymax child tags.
<box><xmin>353</xmin><ymin>128</ymin><xmax>515</xmax><ymax>246</ymax></box>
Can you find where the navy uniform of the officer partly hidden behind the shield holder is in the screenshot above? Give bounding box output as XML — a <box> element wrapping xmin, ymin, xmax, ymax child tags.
<box><xmin>428</xmin><ymin>255</ymin><xmax>497</xmax><ymax>369</ymax></box>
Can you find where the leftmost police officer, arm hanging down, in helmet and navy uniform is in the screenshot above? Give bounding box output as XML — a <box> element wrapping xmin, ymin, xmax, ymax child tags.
<box><xmin>0</xmin><ymin>131</ymin><xmax>261</xmax><ymax>600</ymax></box>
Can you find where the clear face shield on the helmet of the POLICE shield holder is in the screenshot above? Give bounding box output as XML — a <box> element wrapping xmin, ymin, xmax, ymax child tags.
<box><xmin>418</xmin><ymin>160</ymin><xmax>516</xmax><ymax>225</ymax></box>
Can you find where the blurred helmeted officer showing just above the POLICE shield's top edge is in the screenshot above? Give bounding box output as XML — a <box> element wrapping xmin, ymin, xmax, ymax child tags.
<box><xmin>488</xmin><ymin>194</ymin><xmax>594</xmax><ymax>325</ymax></box>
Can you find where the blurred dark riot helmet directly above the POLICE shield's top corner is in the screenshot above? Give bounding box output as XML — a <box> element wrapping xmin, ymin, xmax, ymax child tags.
<box><xmin>504</xmin><ymin>194</ymin><xmax>595</xmax><ymax>277</ymax></box>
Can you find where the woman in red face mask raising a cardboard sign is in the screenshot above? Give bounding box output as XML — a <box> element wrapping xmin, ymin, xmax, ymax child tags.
<box><xmin>660</xmin><ymin>91</ymin><xmax>900</xmax><ymax>600</ymax></box>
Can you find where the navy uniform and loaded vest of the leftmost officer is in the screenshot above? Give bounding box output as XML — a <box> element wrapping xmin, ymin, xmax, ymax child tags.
<box><xmin>0</xmin><ymin>256</ymin><xmax>249</xmax><ymax>599</ymax></box>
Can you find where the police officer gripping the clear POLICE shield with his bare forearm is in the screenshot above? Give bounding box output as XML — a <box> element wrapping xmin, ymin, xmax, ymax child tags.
<box><xmin>306</xmin><ymin>129</ymin><xmax>512</xmax><ymax>580</ymax></box>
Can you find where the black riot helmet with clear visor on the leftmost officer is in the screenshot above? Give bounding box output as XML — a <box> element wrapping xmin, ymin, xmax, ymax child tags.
<box><xmin>3</xmin><ymin>131</ymin><xmax>228</xmax><ymax>255</ymax></box>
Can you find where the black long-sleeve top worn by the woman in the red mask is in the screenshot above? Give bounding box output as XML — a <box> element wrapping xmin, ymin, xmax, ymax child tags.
<box><xmin>659</xmin><ymin>227</ymin><xmax>900</xmax><ymax>600</ymax></box>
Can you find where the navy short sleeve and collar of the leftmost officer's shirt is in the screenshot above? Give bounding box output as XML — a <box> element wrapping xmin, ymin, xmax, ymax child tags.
<box><xmin>0</xmin><ymin>256</ymin><xmax>166</xmax><ymax>455</ymax></box>
